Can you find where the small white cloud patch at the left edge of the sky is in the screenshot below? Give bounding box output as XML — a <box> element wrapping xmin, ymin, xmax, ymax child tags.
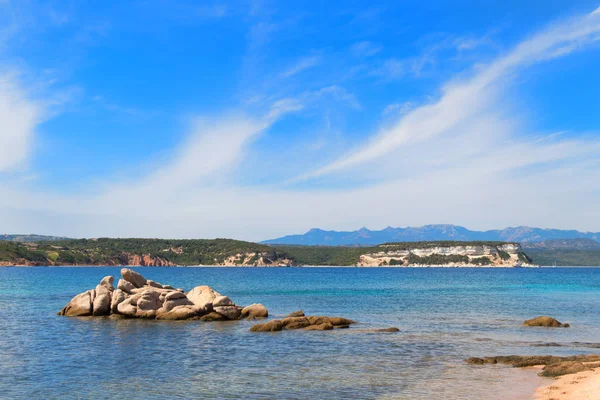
<box><xmin>0</xmin><ymin>75</ymin><xmax>42</xmax><ymax>173</ymax></box>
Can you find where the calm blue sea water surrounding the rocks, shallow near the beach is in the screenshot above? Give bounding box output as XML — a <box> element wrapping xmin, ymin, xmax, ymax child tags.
<box><xmin>0</xmin><ymin>268</ymin><xmax>600</xmax><ymax>399</ymax></box>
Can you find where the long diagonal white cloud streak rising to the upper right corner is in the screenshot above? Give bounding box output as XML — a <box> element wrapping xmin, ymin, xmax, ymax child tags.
<box><xmin>303</xmin><ymin>9</ymin><xmax>600</xmax><ymax>179</ymax></box>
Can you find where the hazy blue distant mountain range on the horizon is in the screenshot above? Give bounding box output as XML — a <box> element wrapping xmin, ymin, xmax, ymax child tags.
<box><xmin>261</xmin><ymin>225</ymin><xmax>600</xmax><ymax>246</ymax></box>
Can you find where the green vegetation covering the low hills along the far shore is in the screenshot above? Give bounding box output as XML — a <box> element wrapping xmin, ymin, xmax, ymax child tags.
<box><xmin>0</xmin><ymin>238</ymin><xmax>529</xmax><ymax>266</ymax></box>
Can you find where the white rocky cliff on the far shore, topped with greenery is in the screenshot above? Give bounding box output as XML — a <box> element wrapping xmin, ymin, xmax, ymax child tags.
<box><xmin>357</xmin><ymin>243</ymin><xmax>534</xmax><ymax>267</ymax></box>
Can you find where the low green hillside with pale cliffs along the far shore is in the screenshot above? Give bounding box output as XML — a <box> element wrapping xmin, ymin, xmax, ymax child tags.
<box><xmin>0</xmin><ymin>239</ymin><xmax>530</xmax><ymax>267</ymax></box>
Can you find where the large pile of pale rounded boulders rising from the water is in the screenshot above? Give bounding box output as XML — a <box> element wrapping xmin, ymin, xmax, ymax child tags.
<box><xmin>58</xmin><ymin>268</ymin><xmax>268</xmax><ymax>321</ymax></box>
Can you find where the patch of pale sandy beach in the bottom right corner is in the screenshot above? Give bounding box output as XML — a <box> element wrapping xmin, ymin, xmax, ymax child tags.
<box><xmin>534</xmin><ymin>368</ymin><xmax>600</xmax><ymax>400</ymax></box>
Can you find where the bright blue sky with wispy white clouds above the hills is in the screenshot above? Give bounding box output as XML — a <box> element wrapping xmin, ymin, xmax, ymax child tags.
<box><xmin>0</xmin><ymin>0</ymin><xmax>600</xmax><ymax>241</ymax></box>
